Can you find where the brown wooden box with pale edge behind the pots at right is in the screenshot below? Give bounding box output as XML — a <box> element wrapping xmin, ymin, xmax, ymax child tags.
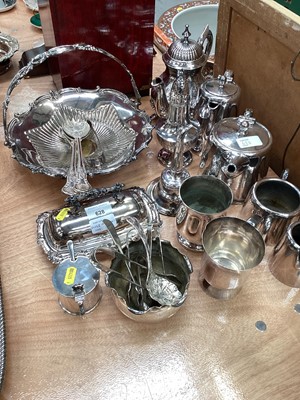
<box><xmin>214</xmin><ymin>0</ymin><xmax>300</xmax><ymax>186</ymax></box>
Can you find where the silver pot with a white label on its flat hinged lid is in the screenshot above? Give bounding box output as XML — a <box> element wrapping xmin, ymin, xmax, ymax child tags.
<box><xmin>204</xmin><ymin>109</ymin><xmax>272</xmax><ymax>202</ymax></box>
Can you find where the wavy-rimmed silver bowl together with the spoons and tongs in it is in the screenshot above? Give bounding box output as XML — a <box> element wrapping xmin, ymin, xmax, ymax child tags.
<box><xmin>96</xmin><ymin>218</ymin><xmax>193</xmax><ymax>323</ymax></box>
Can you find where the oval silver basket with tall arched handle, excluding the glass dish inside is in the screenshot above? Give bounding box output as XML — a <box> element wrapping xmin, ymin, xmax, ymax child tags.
<box><xmin>3</xmin><ymin>44</ymin><xmax>153</xmax><ymax>177</ymax></box>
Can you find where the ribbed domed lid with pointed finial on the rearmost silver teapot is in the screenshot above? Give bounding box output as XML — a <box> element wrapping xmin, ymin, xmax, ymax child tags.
<box><xmin>162</xmin><ymin>25</ymin><xmax>207</xmax><ymax>70</ymax></box>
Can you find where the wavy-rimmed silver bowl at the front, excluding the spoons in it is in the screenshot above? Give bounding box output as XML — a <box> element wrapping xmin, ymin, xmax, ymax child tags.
<box><xmin>104</xmin><ymin>238</ymin><xmax>193</xmax><ymax>323</ymax></box>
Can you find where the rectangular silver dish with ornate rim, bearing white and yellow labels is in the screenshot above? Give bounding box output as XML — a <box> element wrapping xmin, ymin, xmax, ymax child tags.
<box><xmin>37</xmin><ymin>184</ymin><xmax>161</xmax><ymax>264</ymax></box>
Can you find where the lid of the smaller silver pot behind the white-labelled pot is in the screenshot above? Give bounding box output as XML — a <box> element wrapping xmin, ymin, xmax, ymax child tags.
<box><xmin>201</xmin><ymin>70</ymin><xmax>240</xmax><ymax>102</ymax></box>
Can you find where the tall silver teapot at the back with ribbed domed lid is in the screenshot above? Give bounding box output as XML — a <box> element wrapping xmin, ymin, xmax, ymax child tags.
<box><xmin>150</xmin><ymin>25</ymin><xmax>213</xmax><ymax>119</ymax></box>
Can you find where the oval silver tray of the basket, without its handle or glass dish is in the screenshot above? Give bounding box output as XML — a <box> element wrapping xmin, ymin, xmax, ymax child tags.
<box><xmin>6</xmin><ymin>88</ymin><xmax>153</xmax><ymax>177</ymax></box>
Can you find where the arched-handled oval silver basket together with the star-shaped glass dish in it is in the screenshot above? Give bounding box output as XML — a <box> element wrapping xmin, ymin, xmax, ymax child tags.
<box><xmin>3</xmin><ymin>44</ymin><xmax>153</xmax><ymax>177</ymax></box>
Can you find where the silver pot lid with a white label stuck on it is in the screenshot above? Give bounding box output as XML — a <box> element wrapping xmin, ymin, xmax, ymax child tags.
<box><xmin>212</xmin><ymin>109</ymin><xmax>272</xmax><ymax>156</ymax></box>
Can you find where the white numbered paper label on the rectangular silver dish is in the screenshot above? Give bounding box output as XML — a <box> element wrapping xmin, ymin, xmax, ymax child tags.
<box><xmin>84</xmin><ymin>201</ymin><xmax>117</xmax><ymax>233</ymax></box>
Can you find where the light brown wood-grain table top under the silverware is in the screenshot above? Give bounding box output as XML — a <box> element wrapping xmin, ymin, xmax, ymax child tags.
<box><xmin>0</xmin><ymin>1</ymin><xmax>300</xmax><ymax>400</ymax></box>
